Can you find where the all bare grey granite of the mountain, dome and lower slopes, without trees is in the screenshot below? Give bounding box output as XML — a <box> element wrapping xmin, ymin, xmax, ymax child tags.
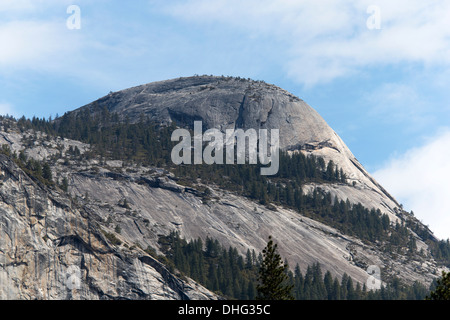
<box><xmin>0</xmin><ymin>77</ymin><xmax>440</xmax><ymax>299</ymax></box>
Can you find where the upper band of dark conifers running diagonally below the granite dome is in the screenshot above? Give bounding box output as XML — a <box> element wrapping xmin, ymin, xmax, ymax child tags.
<box><xmin>0</xmin><ymin>109</ymin><xmax>450</xmax><ymax>288</ymax></box>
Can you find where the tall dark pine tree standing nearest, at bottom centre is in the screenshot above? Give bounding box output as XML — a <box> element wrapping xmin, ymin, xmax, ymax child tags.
<box><xmin>256</xmin><ymin>236</ymin><xmax>293</xmax><ymax>300</ymax></box>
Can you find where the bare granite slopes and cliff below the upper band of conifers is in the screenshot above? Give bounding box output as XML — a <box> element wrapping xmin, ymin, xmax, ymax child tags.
<box><xmin>0</xmin><ymin>128</ymin><xmax>439</xmax><ymax>299</ymax></box>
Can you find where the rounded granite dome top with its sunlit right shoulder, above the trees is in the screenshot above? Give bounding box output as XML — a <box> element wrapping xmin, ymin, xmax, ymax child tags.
<box><xmin>74</xmin><ymin>76</ymin><xmax>399</xmax><ymax>221</ymax></box>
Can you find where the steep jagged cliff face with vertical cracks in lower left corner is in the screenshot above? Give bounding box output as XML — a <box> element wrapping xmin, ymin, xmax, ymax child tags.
<box><xmin>0</xmin><ymin>155</ymin><xmax>215</xmax><ymax>299</ymax></box>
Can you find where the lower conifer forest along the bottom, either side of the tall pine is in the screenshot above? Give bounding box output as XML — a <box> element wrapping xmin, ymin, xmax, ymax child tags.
<box><xmin>147</xmin><ymin>232</ymin><xmax>433</xmax><ymax>300</ymax></box>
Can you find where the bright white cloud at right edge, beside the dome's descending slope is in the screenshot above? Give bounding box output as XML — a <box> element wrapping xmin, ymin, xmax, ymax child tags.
<box><xmin>373</xmin><ymin>128</ymin><xmax>450</xmax><ymax>239</ymax></box>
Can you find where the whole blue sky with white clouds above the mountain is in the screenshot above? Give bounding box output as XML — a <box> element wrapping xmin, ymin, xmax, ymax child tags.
<box><xmin>0</xmin><ymin>0</ymin><xmax>450</xmax><ymax>238</ymax></box>
